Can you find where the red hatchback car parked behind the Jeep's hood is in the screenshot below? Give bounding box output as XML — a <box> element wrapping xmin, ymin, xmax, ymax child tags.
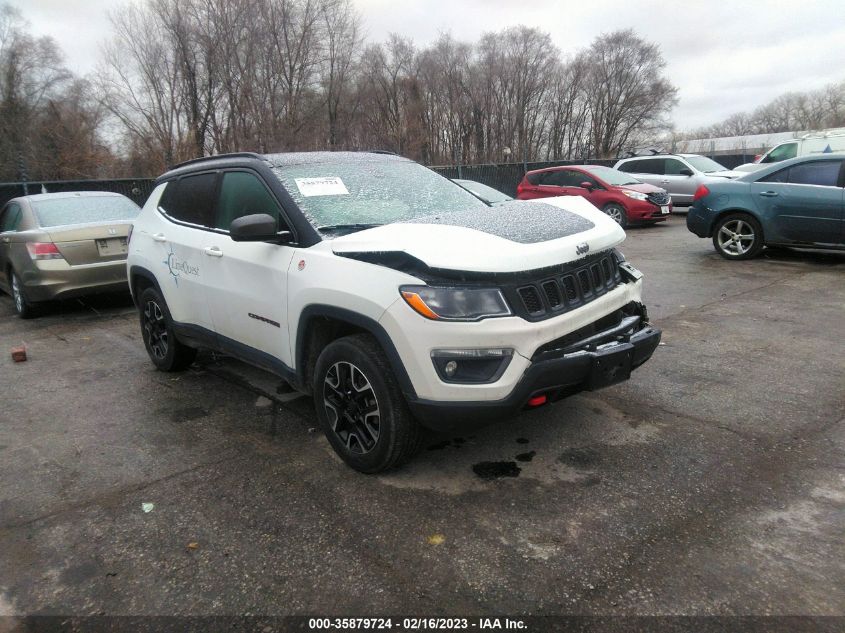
<box><xmin>516</xmin><ymin>165</ymin><xmax>672</xmax><ymax>228</ymax></box>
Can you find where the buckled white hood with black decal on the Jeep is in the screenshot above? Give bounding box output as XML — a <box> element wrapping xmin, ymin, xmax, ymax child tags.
<box><xmin>331</xmin><ymin>196</ymin><xmax>625</xmax><ymax>273</ymax></box>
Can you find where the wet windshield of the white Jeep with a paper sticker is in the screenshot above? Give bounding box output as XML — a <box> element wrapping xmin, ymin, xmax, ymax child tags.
<box><xmin>273</xmin><ymin>159</ymin><xmax>488</xmax><ymax>231</ymax></box>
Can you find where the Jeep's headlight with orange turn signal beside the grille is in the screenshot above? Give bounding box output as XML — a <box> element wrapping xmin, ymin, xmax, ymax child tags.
<box><xmin>399</xmin><ymin>286</ymin><xmax>511</xmax><ymax>321</ymax></box>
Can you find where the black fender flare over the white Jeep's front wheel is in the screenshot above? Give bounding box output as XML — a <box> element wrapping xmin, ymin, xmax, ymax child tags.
<box><xmin>294</xmin><ymin>304</ymin><xmax>417</xmax><ymax>400</ymax></box>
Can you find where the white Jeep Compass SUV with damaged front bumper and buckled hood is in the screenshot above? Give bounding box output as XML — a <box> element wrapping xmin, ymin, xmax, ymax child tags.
<box><xmin>127</xmin><ymin>152</ymin><xmax>660</xmax><ymax>472</ymax></box>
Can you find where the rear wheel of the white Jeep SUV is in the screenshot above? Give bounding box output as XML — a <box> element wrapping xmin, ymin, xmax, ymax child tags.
<box><xmin>138</xmin><ymin>288</ymin><xmax>197</xmax><ymax>371</ymax></box>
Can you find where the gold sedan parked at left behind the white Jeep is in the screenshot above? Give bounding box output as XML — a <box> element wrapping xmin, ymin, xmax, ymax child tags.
<box><xmin>0</xmin><ymin>191</ymin><xmax>140</xmax><ymax>319</ymax></box>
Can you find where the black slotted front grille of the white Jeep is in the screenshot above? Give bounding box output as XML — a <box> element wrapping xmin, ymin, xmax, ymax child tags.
<box><xmin>503</xmin><ymin>252</ymin><xmax>622</xmax><ymax>321</ymax></box>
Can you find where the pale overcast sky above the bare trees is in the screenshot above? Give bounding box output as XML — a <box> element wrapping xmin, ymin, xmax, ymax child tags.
<box><xmin>10</xmin><ymin>0</ymin><xmax>845</xmax><ymax>130</ymax></box>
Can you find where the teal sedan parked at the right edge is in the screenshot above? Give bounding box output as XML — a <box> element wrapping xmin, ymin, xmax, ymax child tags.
<box><xmin>687</xmin><ymin>154</ymin><xmax>845</xmax><ymax>259</ymax></box>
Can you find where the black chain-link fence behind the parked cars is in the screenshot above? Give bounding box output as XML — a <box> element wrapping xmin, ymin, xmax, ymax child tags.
<box><xmin>0</xmin><ymin>154</ymin><xmax>754</xmax><ymax>207</ymax></box>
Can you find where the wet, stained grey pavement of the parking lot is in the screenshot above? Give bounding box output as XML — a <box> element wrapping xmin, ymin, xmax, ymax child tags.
<box><xmin>0</xmin><ymin>216</ymin><xmax>845</xmax><ymax>615</ymax></box>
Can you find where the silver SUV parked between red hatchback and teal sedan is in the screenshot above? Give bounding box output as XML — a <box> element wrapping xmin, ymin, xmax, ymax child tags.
<box><xmin>614</xmin><ymin>154</ymin><xmax>744</xmax><ymax>206</ymax></box>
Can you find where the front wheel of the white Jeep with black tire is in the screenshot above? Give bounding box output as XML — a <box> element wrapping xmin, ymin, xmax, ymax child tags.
<box><xmin>313</xmin><ymin>334</ymin><xmax>424</xmax><ymax>474</ymax></box>
